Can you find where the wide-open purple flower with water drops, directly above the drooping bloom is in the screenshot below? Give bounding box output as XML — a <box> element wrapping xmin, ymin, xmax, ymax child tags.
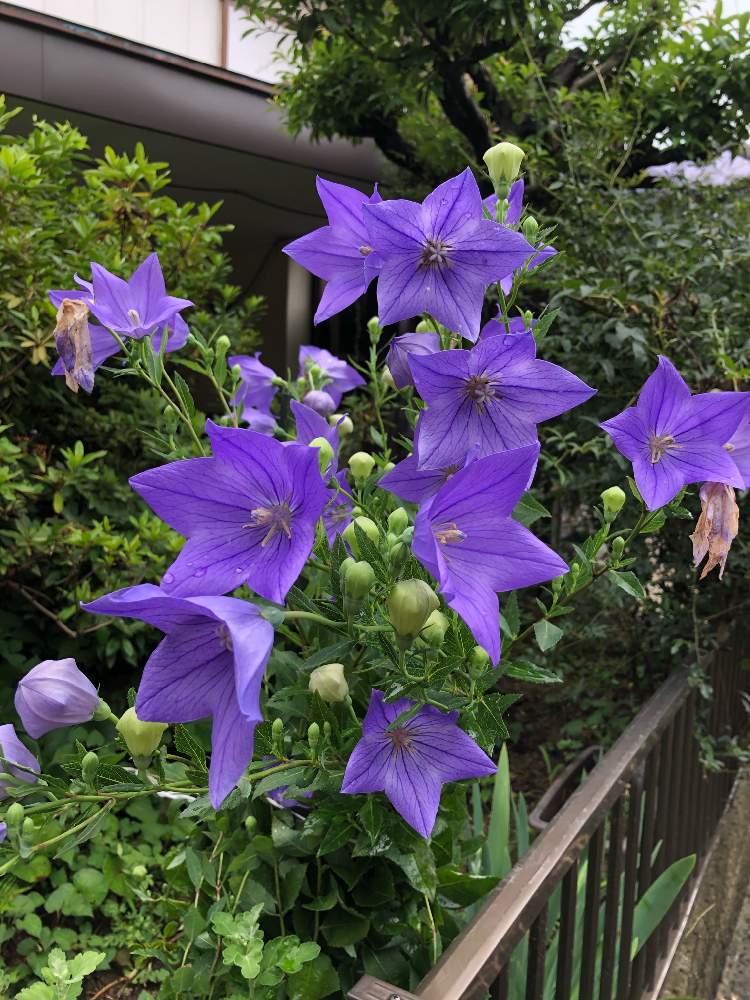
<box><xmin>130</xmin><ymin>421</ymin><xmax>329</xmax><ymax>603</ymax></box>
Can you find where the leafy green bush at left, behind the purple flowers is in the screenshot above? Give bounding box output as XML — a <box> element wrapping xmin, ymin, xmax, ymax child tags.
<box><xmin>0</xmin><ymin>98</ymin><xmax>260</xmax><ymax>699</ymax></box>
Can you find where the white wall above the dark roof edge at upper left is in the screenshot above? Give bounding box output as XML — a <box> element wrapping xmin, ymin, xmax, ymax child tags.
<box><xmin>6</xmin><ymin>0</ymin><xmax>292</xmax><ymax>83</ymax></box>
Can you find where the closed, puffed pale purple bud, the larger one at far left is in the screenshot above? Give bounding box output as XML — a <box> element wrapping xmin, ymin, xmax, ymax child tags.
<box><xmin>15</xmin><ymin>658</ymin><xmax>99</xmax><ymax>740</ymax></box>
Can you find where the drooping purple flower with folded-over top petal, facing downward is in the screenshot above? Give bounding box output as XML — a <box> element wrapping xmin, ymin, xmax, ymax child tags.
<box><xmin>83</xmin><ymin>583</ymin><xmax>273</xmax><ymax>809</ymax></box>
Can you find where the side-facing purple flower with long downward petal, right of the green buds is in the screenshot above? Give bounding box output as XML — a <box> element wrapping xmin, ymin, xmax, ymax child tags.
<box><xmin>412</xmin><ymin>444</ymin><xmax>568</xmax><ymax>664</ymax></box>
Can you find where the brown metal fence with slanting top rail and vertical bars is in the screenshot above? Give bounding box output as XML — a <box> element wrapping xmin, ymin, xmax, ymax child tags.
<box><xmin>349</xmin><ymin>638</ymin><xmax>747</xmax><ymax>1000</ymax></box>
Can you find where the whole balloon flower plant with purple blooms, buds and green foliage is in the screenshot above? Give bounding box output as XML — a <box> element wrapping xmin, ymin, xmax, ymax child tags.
<box><xmin>0</xmin><ymin>133</ymin><xmax>750</xmax><ymax>1000</ymax></box>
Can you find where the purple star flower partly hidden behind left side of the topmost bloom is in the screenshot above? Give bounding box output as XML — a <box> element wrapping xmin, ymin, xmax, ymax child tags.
<box><xmin>284</xmin><ymin>177</ymin><xmax>381</xmax><ymax>323</ymax></box>
